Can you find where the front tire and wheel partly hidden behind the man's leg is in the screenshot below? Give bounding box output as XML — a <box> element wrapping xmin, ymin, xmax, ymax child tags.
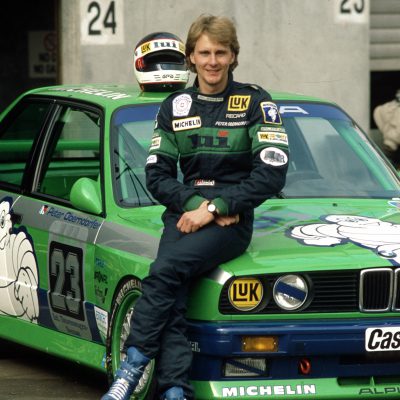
<box><xmin>107</xmin><ymin>278</ymin><xmax>157</xmax><ymax>400</ymax></box>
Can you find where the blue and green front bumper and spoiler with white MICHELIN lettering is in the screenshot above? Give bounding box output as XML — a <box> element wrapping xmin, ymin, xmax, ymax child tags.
<box><xmin>188</xmin><ymin>316</ymin><xmax>400</xmax><ymax>400</ymax></box>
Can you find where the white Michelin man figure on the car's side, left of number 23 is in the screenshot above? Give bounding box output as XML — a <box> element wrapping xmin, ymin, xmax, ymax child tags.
<box><xmin>0</xmin><ymin>201</ymin><xmax>39</xmax><ymax>323</ymax></box>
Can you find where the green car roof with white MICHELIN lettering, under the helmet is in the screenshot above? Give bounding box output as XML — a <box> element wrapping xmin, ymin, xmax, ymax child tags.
<box><xmin>27</xmin><ymin>84</ymin><xmax>334</xmax><ymax>108</ymax></box>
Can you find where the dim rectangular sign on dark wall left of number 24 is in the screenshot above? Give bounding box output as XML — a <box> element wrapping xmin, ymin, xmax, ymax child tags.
<box><xmin>28</xmin><ymin>31</ymin><xmax>57</xmax><ymax>79</ymax></box>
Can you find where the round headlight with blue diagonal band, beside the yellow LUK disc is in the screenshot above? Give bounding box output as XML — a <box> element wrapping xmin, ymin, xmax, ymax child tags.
<box><xmin>273</xmin><ymin>275</ymin><xmax>309</xmax><ymax>311</ymax></box>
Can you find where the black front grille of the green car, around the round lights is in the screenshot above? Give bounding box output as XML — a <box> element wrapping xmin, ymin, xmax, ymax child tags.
<box><xmin>219</xmin><ymin>268</ymin><xmax>400</xmax><ymax>314</ymax></box>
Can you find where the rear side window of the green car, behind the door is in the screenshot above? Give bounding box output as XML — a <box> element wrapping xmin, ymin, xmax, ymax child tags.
<box><xmin>0</xmin><ymin>101</ymin><xmax>51</xmax><ymax>186</ymax></box>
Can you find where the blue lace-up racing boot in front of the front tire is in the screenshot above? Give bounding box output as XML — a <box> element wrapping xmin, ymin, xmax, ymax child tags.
<box><xmin>101</xmin><ymin>347</ymin><xmax>150</xmax><ymax>400</ymax></box>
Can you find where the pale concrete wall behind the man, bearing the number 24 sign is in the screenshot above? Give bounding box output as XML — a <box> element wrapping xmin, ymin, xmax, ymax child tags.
<box><xmin>61</xmin><ymin>0</ymin><xmax>369</xmax><ymax>129</ymax></box>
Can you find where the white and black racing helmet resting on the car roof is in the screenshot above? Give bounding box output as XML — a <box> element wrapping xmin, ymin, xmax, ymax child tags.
<box><xmin>133</xmin><ymin>32</ymin><xmax>189</xmax><ymax>92</ymax></box>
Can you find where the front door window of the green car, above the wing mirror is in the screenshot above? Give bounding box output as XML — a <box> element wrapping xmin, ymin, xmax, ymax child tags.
<box><xmin>37</xmin><ymin>106</ymin><xmax>101</xmax><ymax>200</ymax></box>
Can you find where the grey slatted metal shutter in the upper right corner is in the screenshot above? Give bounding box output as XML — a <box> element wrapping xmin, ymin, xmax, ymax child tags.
<box><xmin>370</xmin><ymin>0</ymin><xmax>400</xmax><ymax>71</ymax></box>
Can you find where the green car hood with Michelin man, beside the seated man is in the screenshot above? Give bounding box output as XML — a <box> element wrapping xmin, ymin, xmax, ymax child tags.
<box><xmin>220</xmin><ymin>199</ymin><xmax>400</xmax><ymax>275</ymax></box>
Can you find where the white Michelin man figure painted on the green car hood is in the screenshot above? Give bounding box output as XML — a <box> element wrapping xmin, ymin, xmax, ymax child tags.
<box><xmin>290</xmin><ymin>215</ymin><xmax>400</xmax><ymax>265</ymax></box>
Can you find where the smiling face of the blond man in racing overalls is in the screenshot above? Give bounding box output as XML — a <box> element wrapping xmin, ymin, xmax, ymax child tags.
<box><xmin>190</xmin><ymin>34</ymin><xmax>235</xmax><ymax>94</ymax></box>
